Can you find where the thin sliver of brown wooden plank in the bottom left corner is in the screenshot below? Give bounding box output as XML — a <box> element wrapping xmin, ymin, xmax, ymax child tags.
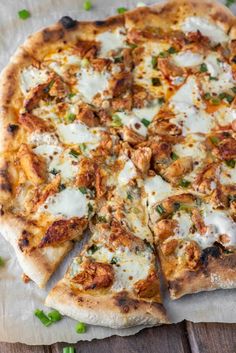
<box><xmin>0</xmin><ymin>343</ymin><xmax>52</xmax><ymax>353</ymax></box>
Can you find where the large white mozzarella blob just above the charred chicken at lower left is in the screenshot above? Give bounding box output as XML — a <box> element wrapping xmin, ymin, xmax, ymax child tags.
<box><xmin>39</xmin><ymin>188</ymin><xmax>88</xmax><ymax>218</ymax></box>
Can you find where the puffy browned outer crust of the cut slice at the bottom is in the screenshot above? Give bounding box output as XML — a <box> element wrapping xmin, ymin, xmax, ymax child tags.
<box><xmin>45</xmin><ymin>278</ymin><xmax>169</xmax><ymax>328</ymax></box>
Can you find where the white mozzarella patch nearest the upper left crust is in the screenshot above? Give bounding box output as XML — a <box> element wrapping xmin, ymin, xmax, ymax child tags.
<box><xmin>20</xmin><ymin>66</ymin><xmax>49</xmax><ymax>95</ymax></box>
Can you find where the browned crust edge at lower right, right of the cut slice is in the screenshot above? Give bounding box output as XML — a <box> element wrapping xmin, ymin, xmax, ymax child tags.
<box><xmin>167</xmin><ymin>254</ymin><xmax>236</xmax><ymax>299</ymax></box>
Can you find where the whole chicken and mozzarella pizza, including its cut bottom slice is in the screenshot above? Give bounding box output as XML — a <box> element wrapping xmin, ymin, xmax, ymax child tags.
<box><xmin>0</xmin><ymin>0</ymin><xmax>236</xmax><ymax>327</ymax></box>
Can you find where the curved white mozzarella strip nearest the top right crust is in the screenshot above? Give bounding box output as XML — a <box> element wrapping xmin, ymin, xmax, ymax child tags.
<box><xmin>181</xmin><ymin>16</ymin><xmax>229</xmax><ymax>43</ymax></box>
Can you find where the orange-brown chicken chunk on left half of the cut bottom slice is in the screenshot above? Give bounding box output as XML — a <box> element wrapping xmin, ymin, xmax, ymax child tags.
<box><xmin>72</xmin><ymin>260</ymin><xmax>114</xmax><ymax>290</ymax></box>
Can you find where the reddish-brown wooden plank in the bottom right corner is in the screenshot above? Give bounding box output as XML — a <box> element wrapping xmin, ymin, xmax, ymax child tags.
<box><xmin>187</xmin><ymin>322</ymin><xmax>236</xmax><ymax>353</ymax></box>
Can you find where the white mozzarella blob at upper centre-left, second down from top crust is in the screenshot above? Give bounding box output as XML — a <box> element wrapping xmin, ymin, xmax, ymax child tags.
<box><xmin>77</xmin><ymin>68</ymin><xmax>110</xmax><ymax>103</ymax></box>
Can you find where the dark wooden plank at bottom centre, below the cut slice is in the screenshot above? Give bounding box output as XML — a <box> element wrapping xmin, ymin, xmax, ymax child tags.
<box><xmin>52</xmin><ymin>323</ymin><xmax>192</xmax><ymax>353</ymax></box>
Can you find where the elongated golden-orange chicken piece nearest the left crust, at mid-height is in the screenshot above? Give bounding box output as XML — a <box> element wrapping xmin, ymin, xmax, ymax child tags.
<box><xmin>17</xmin><ymin>144</ymin><xmax>46</xmax><ymax>185</ymax></box>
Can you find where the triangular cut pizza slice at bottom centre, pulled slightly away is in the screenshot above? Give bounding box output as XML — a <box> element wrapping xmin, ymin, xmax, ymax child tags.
<box><xmin>46</xmin><ymin>218</ymin><xmax>168</xmax><ymax>328</ymax></box>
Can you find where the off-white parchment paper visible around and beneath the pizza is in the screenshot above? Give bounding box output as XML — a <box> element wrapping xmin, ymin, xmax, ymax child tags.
<box><xmin>0</xmin><ymin>0</ymin><xmax>236</xmax><ymax>345</ymax></box>
